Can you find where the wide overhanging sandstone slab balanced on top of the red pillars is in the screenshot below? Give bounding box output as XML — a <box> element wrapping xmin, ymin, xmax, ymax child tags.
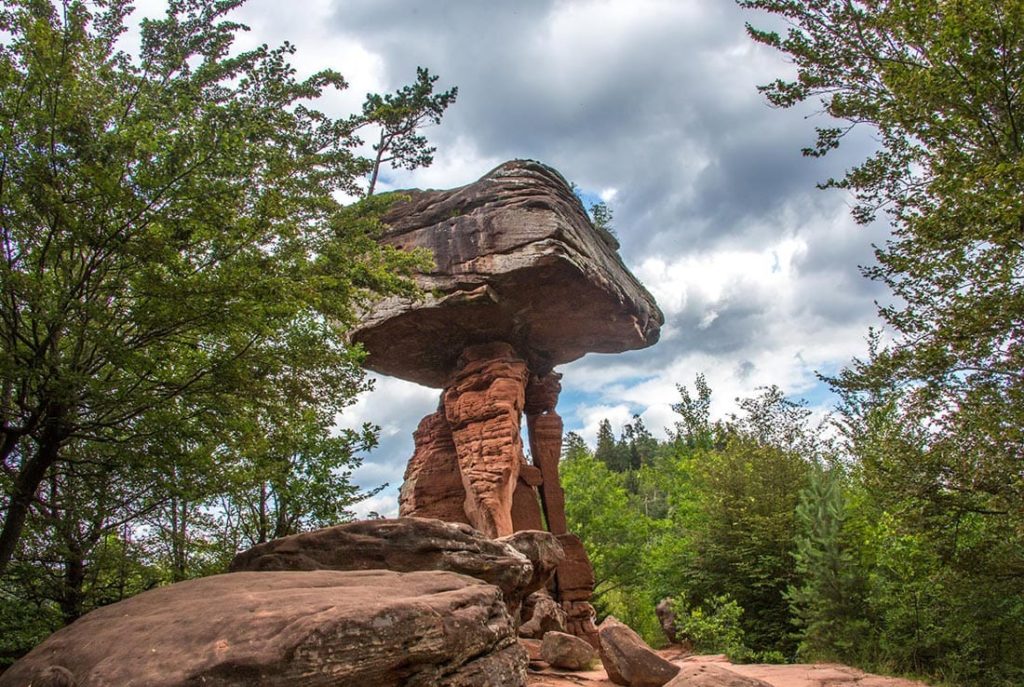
<box><xmin>352</xmin><ymin>160</ymin><xmax>665</xmax><ymax>387</ymax></box>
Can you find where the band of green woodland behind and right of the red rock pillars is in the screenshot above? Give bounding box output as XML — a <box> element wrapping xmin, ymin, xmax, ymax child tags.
<box><xmin>562</xmin><ymin>377</ymin><xmax>1024</xmax><ymax>686</ymax></box>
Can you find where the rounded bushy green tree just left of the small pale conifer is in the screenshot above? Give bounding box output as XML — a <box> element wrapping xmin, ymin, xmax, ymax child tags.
<box><xmin>662</xmin><ymin>384</ymin><xmax>823</xmax><ymax>656</ymax></box>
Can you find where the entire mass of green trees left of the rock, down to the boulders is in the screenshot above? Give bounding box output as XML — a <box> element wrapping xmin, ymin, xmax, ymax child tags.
<box><xmin>0</xmin><ymin>0</ymin><xmax>455</xmax><ymax>667</ymax></box>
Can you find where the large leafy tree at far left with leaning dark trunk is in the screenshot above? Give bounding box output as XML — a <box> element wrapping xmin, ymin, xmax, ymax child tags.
<box><xmin>0</xmin><ymin>0</ymin><xmax>436</xmax><ymax>571</ymax></box>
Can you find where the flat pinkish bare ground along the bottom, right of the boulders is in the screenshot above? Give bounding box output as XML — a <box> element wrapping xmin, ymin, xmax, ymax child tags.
<box><xmin>528</xmin><ymin>648</ymin><xmax>927</xmax><ymax>687</ymax></box>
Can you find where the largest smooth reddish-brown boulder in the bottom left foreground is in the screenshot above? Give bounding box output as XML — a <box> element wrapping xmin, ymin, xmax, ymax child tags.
<box><xmin>0</xmin><ymin>570</ymin><xmax>526</xmax><ymax>687</ymax></box>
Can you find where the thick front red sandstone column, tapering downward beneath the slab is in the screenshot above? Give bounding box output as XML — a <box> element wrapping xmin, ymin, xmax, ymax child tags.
<box><xmin>441</xmin><ymin>342</ymin><xmax>528</xmax><ymax>538</ymax></box>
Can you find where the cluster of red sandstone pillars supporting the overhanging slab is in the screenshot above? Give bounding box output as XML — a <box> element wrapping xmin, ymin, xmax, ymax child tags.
<box><xmin>399</xmin><ymin>342</ymin><xmax>597</xmax><ymax>647</ymax></box>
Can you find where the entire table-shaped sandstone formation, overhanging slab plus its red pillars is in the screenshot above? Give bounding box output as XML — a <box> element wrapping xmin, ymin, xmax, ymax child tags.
<box><xmin>352</xmin><ymin>160</ymin><xmax>665</xmax><ymax>646</ymax></box>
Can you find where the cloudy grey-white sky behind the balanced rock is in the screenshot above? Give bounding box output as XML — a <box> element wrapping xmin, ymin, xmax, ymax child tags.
<box><xmin>139</xmin><ymin>0</ymin><xmax>887</xmax><ymax>514</ymax></box>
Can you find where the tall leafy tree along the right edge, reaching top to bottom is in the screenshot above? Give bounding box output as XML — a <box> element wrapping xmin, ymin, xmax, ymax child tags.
<box><xmin>739</xmin><ymin>0</ymin><xmax>1024</xmax><ymax>684</ymax></box>
